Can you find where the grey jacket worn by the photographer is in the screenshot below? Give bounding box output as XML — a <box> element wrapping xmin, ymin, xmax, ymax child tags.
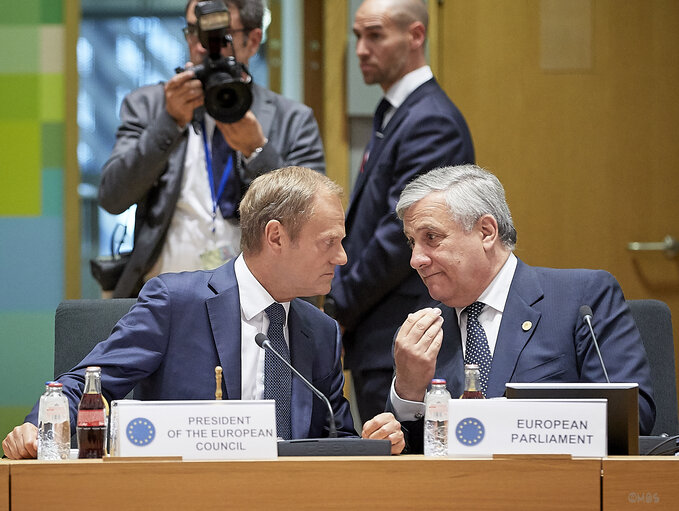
<box><xmin>99</xmin><ymin>84</ymin><xmax>325</xmax><ymax>298</ymax></box>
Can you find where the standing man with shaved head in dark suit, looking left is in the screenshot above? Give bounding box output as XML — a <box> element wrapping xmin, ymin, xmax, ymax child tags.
<box><xmin>325</xmin><ymin>0</ymin><xmax>474</xmax><ymax>420</ymax></box>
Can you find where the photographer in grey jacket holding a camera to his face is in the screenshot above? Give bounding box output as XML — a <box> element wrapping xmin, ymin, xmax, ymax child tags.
<box><xmin>99</xmin><ymin>0</ymin><xmax>325</xmax><ymax>297</ymax></box>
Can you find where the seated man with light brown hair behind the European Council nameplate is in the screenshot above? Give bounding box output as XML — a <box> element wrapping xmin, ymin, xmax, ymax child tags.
<box><xmin>3</xmin><ymin>167</ymin><xmax>404</xmax><ymax>458</ymax></box>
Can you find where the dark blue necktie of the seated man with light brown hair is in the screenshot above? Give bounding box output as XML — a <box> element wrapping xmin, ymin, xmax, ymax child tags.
<box><xmin>264</xmin><ymin>302</ymin><xmax>292</xmax><ymax>440</ymax></box>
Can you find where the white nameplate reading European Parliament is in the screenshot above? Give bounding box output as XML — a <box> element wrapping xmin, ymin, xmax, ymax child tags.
<box><xmin>448</xmin><ymin>399</ymin><xmax>607</xmax><ymax>458</ymax></box>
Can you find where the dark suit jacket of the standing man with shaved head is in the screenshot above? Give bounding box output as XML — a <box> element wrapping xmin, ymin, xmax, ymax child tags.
<box><xmin>330</xmin><ymin>78</ymin><xmax>474</xmax><ymax>371</ymax></box>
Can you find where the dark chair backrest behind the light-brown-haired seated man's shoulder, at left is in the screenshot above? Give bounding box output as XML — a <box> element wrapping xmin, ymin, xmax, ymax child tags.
<box><xmin>54</xmin><ymin>298</ymin><xmax>136</xmax><ymax>378</ymax></box>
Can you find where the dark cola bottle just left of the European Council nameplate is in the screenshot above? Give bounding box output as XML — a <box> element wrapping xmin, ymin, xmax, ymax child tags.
<box><xmin>76</xmin><ymin>366</ymin><xmax>107</xmax><ymax>458</ymax></box>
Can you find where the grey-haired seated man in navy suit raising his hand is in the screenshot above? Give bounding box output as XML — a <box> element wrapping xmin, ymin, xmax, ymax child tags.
<box><xmin>390</xmin><ymin>165</ymin><xmax>655</xmax><ymax>451</ymax></box>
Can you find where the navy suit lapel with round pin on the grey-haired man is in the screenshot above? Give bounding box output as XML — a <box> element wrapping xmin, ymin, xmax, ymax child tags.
<box><xmin>487</xmin><ymin>261</ymin><xmax>544</xmax><ymax>397</ymax></box>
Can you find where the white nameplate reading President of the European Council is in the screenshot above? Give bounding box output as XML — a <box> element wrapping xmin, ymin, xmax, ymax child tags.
<box><xmin>111</xmin><ymin>399</ymin><xmax>277</xmax><ymax>460</ymax></box>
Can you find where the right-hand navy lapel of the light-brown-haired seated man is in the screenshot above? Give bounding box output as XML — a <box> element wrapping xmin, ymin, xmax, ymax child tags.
<box><xmin>288</xmin><ymin>300</ymin><xmax>314</xmax><ymax>438</ymax></box>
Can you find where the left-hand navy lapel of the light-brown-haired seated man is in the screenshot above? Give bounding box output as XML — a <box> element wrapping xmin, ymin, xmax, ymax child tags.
<box><xmin>205</xmin><ymin>259</ymin><xmax>241</xmax><ymax>399</ymax></box>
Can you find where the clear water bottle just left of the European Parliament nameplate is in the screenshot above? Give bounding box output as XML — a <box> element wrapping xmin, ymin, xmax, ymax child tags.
<box><xmin>424</xmin><ymin>379</ymin><xmax>450</xmax><ymax>456</ymax></box>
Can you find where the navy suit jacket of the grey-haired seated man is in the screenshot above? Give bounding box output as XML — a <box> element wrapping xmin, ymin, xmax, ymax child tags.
<box><xmin>398</xmin><ymin>261</ymin><xmax>655</xmax><ymax>452</ymax></box>
